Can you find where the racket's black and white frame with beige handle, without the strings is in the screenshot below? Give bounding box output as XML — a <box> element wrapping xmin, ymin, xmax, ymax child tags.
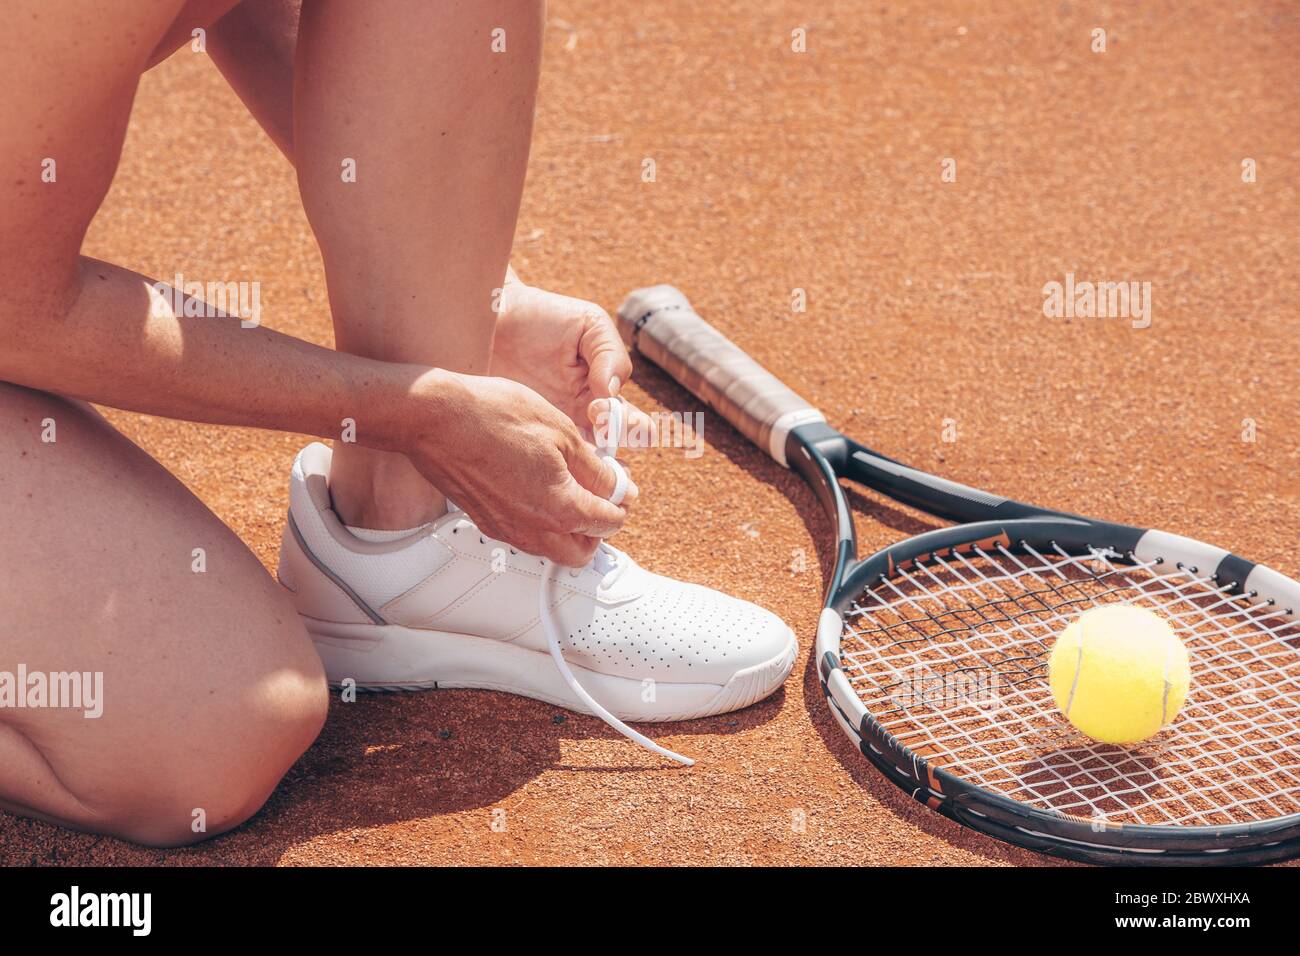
<box><xmin>619</xmin><ymin>285</ymin><xmax>1300</xmax><ymax>865</ymax></box>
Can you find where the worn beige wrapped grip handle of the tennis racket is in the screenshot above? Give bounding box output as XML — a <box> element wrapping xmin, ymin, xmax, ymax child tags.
<box><xmin>619</xmin><ymin>285</ymin><xmax>826</xmax><ymax>467</ymax></box>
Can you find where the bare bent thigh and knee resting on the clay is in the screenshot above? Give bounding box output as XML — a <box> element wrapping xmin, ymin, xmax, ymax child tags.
<box><xmin>0</xmin><ymin>384</ymin><xmax>326</xmax><ymax>844</ymax></box>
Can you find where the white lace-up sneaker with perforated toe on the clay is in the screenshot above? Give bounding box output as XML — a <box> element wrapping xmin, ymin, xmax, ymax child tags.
<box><xmin>280</xmin><ymin>442</ymin><xmax>797</xmax><ymax>721</ymax></box>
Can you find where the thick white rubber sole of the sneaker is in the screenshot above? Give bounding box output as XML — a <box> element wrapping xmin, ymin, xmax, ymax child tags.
<box><xmin>303</xmin><ymin>617</ymin><xmax>798</xmax><ymax>722</ymax></box>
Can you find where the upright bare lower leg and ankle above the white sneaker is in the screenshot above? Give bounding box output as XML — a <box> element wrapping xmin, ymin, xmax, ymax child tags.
<box><xmin>294</xmin><ymin>0</ymin><xmax>542</xmax><ymax>529</ymax></box>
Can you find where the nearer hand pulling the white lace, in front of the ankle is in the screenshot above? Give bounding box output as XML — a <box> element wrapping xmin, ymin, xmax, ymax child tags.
<box><xmin>402</xmin><ymin>369</ymin><xmax>637</xmax><ymax>567</ymax></box>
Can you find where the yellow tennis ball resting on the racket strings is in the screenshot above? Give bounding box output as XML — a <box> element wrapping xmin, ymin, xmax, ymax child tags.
<box><xmin>1048</xmin><ymin>605</ymin><xmax>1192</xmax><ymax>744</ymax></box>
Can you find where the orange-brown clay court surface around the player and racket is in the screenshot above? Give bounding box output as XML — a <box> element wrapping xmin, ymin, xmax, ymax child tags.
<box><xmin>0</xmin><ymin>0</ymin><xmax>1300</xmax><ymax>865</ymax></box>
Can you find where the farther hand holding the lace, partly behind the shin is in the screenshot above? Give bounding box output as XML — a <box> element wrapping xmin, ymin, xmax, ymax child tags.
<box><xmin>491</xmin><ymin>271</ymin><xmax>654</xmax><ymax>447</ymax></box>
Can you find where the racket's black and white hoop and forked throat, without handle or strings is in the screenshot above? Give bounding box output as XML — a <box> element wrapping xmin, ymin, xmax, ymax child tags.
<box><xmin>785</xmin><ymin>423</ymin><xmax>1300</xmax><ymax>865</ymax></box>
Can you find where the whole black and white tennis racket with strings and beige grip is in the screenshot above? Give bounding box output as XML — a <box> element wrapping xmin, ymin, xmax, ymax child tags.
<box><xmin>619</xmin><ymin>285</ymin><xmax>1300</xmax><ymax>865</ymax></box>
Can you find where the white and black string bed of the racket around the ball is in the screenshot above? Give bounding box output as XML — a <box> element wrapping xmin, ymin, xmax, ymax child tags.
<box><xmin>841</xmin><ymin>546</ymin><xmax>1300</xmax><ymax>826</ymax></box>
